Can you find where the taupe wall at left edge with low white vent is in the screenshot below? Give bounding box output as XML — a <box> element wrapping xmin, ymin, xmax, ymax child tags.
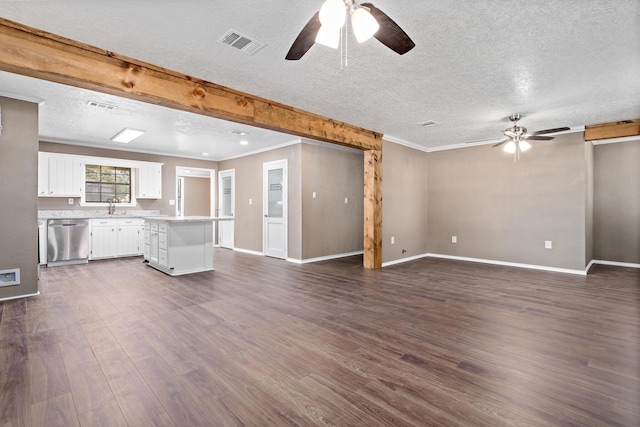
<box><xmin>0</xmin><ymin>97</ymin><xmax>38</xmax><ymax>299</ymax></box>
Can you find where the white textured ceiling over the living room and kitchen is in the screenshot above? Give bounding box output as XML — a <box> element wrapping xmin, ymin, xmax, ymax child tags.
<box><xmin>0</xmin><ymin>0</ymin><xmax>640</xmax><ymax>158</ymax></box>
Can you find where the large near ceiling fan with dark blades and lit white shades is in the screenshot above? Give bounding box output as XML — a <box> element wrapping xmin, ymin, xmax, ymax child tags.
<box><xmin>285</xmin><ymin>0</ymin><xmax>415</xmax><ymax>61</ymax></box>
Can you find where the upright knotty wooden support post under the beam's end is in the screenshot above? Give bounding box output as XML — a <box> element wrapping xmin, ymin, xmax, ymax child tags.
<box><xmin>364</xmin><ymin>149</ymin><xmax>382</xmax><ymax>269</ymax></box>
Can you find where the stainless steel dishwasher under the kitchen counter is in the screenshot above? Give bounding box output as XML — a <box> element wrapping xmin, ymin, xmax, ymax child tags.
<box><xmin>47</xmin><ymin>219</ymin><xmax>90</xmax><ymax>267</ymax></box>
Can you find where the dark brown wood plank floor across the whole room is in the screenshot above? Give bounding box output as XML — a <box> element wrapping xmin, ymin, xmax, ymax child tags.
<box><xmin>0</xmin><ymin>249</ymin><xmax>640</xmax><ymax>427</ymax></box>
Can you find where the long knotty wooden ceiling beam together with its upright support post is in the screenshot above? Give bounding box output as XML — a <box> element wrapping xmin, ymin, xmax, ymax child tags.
<box><xmin>0</xmin><ymin>18</ymin><xmax>382</xmax><ymax>269</ymax></box>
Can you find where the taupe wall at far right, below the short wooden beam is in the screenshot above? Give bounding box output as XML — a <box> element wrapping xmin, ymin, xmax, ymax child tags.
<box><xmin>593</xmin><ymin>141</ymin><xmax>640</xmax><ymax>264</ymax></box>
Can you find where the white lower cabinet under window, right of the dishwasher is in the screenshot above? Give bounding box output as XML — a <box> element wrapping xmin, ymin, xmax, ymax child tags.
<box><xmin>89</xmin><ymin>218</ymin><xmax>143</xmax><ymax>260</ymax></box>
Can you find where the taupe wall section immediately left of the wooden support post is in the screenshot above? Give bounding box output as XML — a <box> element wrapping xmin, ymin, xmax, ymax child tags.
<box><xmin>302</xmin><ymin>144</ymin><xmax>364</xmax><ymax>259</ymax></box>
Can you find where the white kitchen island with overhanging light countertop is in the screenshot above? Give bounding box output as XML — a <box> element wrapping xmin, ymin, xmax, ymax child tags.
<box><xmin>143</xmin><ymin>216</ymin><xmax>233</xmax><ymax>276</ymax></box>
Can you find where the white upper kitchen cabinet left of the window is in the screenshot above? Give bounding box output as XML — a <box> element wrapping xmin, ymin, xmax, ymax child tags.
<box><xmin>38</xmin><ymin>152</ymin><xmax>84</xmax><ymax>197</ymax></box>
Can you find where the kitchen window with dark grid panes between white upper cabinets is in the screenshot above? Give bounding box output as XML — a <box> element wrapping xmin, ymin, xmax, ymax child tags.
<box><xmin>84</xmin><ymin>164</ymin><xmax>132</xmax><ymax>204</ymax></box>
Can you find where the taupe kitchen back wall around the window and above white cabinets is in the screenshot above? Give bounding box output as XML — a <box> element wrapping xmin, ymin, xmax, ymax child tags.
<box><xmin>38</xmin><ymin>142</ymin><xmax>218</xmax><ymax>215</ymax></box>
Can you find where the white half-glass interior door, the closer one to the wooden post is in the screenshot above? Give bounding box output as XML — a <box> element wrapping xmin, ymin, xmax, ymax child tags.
<box><xmin>262</xmin><ymin>159</ymin><xmax>288</xmax><ymax>259</ymax></box>
